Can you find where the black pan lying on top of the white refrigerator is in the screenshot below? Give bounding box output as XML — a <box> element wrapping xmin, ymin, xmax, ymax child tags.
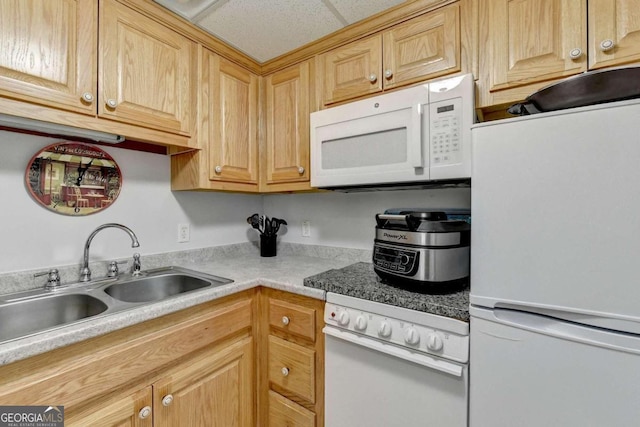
<box><xmin>507</xmin><ymin>67</ymin><xmax>640</xmax><ymax>116</ymax></box>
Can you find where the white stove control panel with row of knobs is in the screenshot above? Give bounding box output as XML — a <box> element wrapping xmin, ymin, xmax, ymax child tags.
<box><xmin>324</xmin><ymin>302</ymin><xmax>469</xmax><ymax>363</ymax></box>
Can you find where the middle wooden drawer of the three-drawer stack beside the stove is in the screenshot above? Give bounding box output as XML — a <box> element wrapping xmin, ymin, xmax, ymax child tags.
<box><xmin>268</xmin><ymin>335</ymin><xmax>316</xmax><ymax>403</ymax></box>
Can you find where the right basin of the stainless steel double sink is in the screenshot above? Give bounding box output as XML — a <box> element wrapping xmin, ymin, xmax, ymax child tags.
<box><xmin>104</xmin><ymin>273</ymin><xmax>222</xmax><ymax>302</ymax></box>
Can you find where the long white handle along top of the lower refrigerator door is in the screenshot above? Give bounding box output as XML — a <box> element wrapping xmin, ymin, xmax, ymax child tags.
<box><xmin>482</xmin><ymin>308</ymin><xmax>640</xmax><ymax>354</ymax></box>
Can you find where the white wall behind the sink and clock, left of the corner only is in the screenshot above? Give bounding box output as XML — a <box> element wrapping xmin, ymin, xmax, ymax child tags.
<box><xmin>0</xmin><ymin>131</ymin><xmax>262</xmax><ymax>273</ymax></box>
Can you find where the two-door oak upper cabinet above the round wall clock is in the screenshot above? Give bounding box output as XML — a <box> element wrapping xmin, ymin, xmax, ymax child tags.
<box><xmin>0</xmin><ymin>0</ymin><xmax>197</xmax><ymax>151</ymax></box>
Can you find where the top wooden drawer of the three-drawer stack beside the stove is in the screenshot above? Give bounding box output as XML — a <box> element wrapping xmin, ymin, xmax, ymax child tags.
<box><xmin>269</xmin><ymin>299</ymin><xmax>316</xmax><ymax>341</ymax></box>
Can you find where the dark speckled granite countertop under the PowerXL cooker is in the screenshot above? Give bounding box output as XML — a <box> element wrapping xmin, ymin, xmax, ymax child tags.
<box><xmin>304</xmin><ymin>262</ymin><xmax>469</xmax><ymax>322</ymax></box>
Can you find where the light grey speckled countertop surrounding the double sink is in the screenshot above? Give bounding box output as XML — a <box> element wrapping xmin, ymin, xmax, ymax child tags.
<box><xmin>0</xmin><ymin>244</ymin><xmax>370</xmax><ymax>365</ymax></box>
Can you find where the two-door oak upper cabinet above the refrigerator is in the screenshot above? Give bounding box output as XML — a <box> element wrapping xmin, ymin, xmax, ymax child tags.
<box><xmin>478</xmin><ymin>0</ymin><xmax>640</xmax><ymax>107</ymax></box>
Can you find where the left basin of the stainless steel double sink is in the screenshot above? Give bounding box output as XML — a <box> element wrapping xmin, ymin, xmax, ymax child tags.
<box><xmin>0</xmin><ymin>294</ymin><xmax>107</xmax><ymax>342</ymax></box>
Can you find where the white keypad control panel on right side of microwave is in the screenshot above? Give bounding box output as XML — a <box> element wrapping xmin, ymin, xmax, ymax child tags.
<box><xmin>429</xmin><ymin>98</ymin><xmax>463</xmax><ymax>166</ymax></box>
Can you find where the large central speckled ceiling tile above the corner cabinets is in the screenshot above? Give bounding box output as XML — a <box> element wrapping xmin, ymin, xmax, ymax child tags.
<box><xmin>196</xmin><ymin>0</ymin><xmax>342</xmax><ymax>62</ymax></box>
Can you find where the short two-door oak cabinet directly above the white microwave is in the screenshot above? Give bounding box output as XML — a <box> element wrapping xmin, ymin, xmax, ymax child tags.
<box><xmin>319</xmin><ymin>3</ymin><xmax>461</xmax><ymax>105</ymax></box>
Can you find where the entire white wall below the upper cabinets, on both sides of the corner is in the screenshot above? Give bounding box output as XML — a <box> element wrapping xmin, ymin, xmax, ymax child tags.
<box><xmin>0</xmin><ymin>131</ymin><xmax>471</xmax><ymax>274</ymax></box>
